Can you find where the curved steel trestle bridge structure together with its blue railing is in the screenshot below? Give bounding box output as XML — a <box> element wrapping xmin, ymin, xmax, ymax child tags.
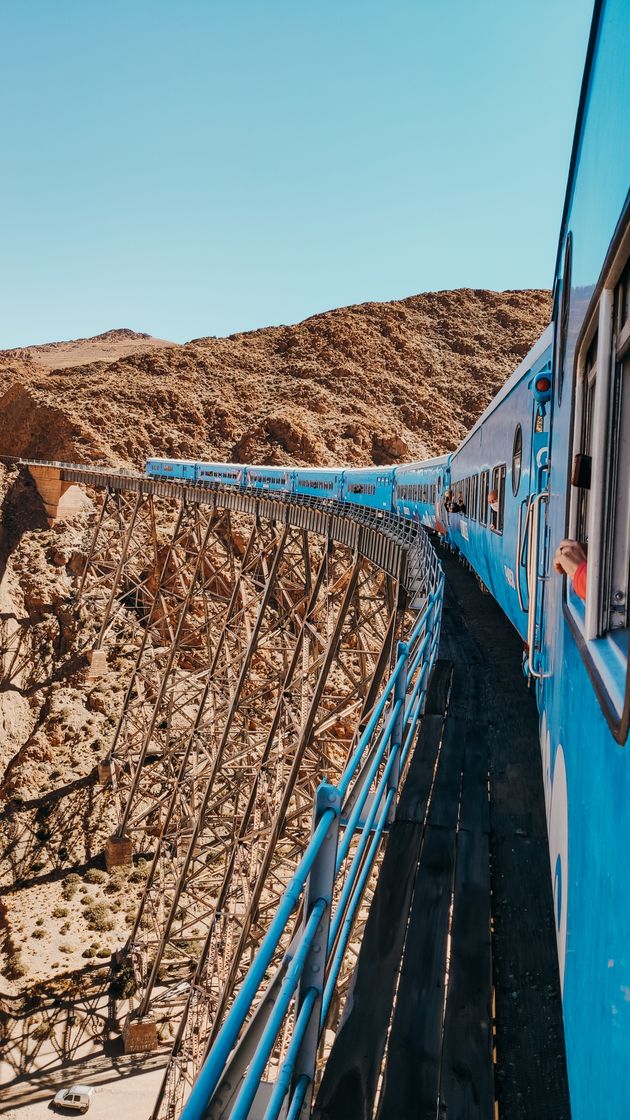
<box><xmin>20</xmin><ymin>460</ymin><xmax>443</xmax><ymax>1120</ymax></box>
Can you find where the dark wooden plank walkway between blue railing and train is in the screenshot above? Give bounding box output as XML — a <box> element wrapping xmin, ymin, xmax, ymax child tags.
<box><xmin>315</xmin><ymin>546</ymin><xmax>569</xmax><ymax>1120</ymax></box>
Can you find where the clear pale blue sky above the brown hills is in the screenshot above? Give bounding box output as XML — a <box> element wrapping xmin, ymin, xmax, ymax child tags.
<box><xmin>0</xmin><ymin>0</ymin><xmax>592</xmax><ymax>347</ymax></box>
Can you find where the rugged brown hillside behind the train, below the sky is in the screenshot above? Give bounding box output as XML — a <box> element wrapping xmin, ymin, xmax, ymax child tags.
<box><xmin>0</xmin><ymin>289</ymin><xmax>550</xmax><ymax>466</ymax></box>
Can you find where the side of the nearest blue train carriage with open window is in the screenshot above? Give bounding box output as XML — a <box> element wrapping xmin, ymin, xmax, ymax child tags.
<box><xmin>537</xmin><ymin>0</ymin><xmax>630</xmax><ymax>1120</ymax></box>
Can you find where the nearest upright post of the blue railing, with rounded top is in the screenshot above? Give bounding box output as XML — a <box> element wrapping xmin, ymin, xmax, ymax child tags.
<box><xmin>289</xmin><ymin>782</ymin><xmax>341</xmax><ymax>1117</ymax></box>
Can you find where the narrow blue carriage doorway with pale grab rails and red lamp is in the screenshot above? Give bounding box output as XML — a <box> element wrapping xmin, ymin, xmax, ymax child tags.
<box><xmin>512</xmin><ymin>353</ymin><xmax>552</xmax><ymax>679</ymax></box>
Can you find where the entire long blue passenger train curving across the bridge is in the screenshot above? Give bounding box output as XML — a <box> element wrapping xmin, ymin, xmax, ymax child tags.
<box><xmin>147</xmin><ymin>0</ymin><xmax>630</xmax><ymax>1120</ymax></box>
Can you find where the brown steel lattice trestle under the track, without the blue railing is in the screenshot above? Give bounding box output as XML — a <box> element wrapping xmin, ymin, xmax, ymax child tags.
<box><xmin>11</xmin><ymin>461</ymin><xmax>439</xmax><ymax>1117</ymax></box>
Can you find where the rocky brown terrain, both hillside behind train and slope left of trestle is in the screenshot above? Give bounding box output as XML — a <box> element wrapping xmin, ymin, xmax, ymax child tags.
<box><xmin>0</xmin><ymin>290</ymin><xmax>550</xmax><ymax>1093</ymax></box>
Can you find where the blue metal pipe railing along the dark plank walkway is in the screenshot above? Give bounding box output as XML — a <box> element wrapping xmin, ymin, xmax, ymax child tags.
<box><xmin>182</xmin><ymin>556</ymin><xmax>444</xmax><ymax>1120</ymax></box>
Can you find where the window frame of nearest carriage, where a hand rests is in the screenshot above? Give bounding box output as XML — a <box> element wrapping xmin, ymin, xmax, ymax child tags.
<box><xmin>563</xmin><ymin>215</ymin><xmax>630</xmax><ymax>745</ymax></box>
